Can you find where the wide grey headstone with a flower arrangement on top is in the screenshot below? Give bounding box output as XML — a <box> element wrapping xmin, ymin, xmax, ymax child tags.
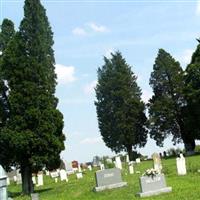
<box><xmin>138</xmin><ymin>174</ymin><xmax>172</xmax><ymax>197</ymax></box>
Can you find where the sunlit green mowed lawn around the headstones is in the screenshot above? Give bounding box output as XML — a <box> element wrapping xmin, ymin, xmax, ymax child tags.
<box><xmin>8</xmin><ymin>155</ymin><xmax>200</xmax><ymax>200</ymax></box>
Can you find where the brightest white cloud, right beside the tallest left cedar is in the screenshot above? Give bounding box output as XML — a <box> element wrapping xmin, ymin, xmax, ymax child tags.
<box><xmin>55</xmin><ymin>64</ymin><xmax>76</xmax><ymax>84</ymax></box>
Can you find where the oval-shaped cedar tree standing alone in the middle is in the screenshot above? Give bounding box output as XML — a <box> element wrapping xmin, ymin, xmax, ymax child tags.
<box><xmin>95</xmin><ymin>52</ymin><xmax>147</xmax><ymax>160</ymax></box>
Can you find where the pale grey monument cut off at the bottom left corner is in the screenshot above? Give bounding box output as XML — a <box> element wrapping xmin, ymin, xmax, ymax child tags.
<box><xmin>0</xmin><ymin>165</ymin><xmax>8</xmax><ymax>200</ymax></box>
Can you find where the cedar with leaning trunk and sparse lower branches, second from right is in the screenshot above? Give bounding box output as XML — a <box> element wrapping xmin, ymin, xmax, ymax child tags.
<box><xmin>149</xmin><ymin>49</ymin><xmax>194</xmax><ymax>152</ymax></box>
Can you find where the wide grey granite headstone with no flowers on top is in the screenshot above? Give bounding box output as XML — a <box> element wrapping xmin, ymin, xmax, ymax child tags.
<box><xmin>94</xmin><ymin>168</ymin><xmax>127</xmax><ymax>192</ymax></box>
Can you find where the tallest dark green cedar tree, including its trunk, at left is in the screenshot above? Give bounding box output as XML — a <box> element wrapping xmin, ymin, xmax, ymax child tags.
<box><xmin>1</xmin><ymin>0</ymin><xmax>65</xmax><ymax>194</ymax></box>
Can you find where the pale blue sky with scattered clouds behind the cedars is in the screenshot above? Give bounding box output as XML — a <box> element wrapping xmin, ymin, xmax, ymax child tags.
<box><xmin>0</xmin><ymin>0</ymin><xmax>200</xmax><ymax>162</ymax></box>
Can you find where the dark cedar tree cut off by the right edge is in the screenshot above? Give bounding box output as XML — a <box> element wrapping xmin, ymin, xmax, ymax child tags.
<box><xmin>185</xmin><ymin>41</ymin><xmax>200</xmax><ymax>148</ymax></box>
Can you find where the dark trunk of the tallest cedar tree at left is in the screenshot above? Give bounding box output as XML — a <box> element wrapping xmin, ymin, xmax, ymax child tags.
<box><xmin>21</xmin><ymin>165</ymin><xmax>34</xmax><ymax>195</ymax></box>
